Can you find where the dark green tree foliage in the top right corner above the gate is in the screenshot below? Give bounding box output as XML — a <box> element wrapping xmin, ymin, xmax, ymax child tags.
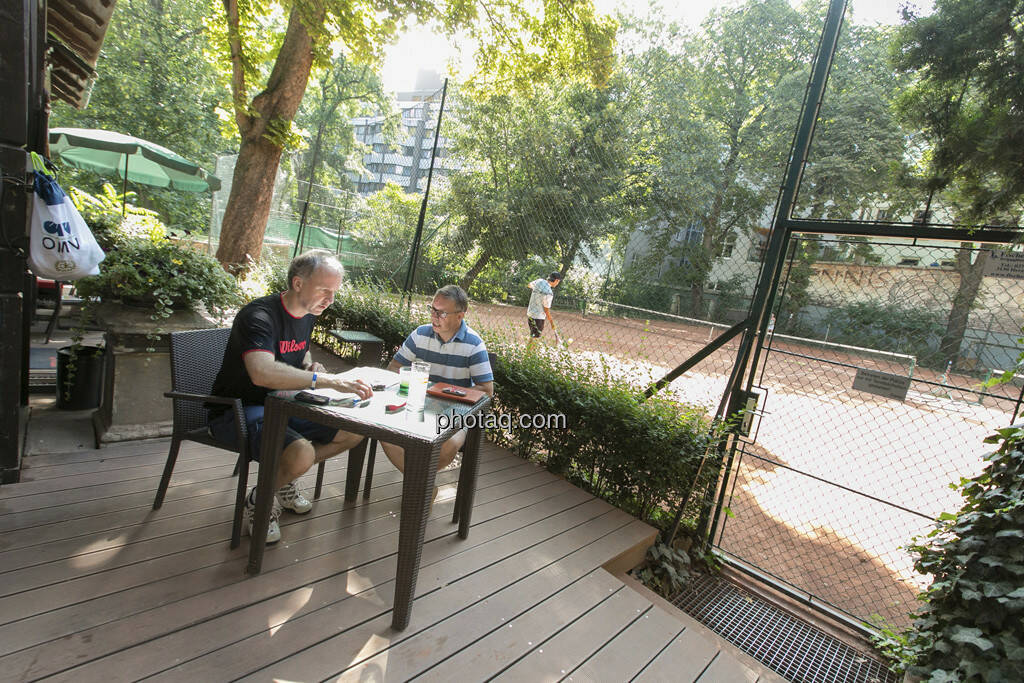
<box><xmin>893</xmin><ymin>0</ymin><xmax>1024</xmax><ymax>220</ymax></box>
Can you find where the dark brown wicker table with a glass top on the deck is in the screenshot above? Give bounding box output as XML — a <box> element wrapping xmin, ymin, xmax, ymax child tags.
<box><xmin>247</xmin><ymin>388</ymin><xmax>490</xmax><ymax>631</ymax></box>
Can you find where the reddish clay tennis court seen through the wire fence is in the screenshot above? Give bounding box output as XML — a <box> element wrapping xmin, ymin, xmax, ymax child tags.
<box><xmin>467</xmin><ymin>304</ymin><xmax>1020</xmax><ymax>625</ymax></box>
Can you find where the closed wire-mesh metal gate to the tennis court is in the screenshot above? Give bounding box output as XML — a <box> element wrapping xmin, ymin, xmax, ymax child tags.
<box><xmin>712</xmin><ymin>234</ymin><xmax>1024</xmax><ymax>626</ymax></box>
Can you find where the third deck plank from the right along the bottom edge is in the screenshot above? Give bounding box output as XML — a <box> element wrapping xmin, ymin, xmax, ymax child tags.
<box><xmin>568</xmin><ymin>606</ymin><xmax>685</xmax><ymax>681</ymax></box>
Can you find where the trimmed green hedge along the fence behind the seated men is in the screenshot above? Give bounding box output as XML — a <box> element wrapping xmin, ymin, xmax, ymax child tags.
<box><xmin>317</xmin><ymin>286</ymin><xmax>718</xmax><ymax>526</ymax></box>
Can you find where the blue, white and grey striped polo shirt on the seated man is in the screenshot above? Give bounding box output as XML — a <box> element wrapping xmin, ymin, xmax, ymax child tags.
<box><xmin>394</xmin><ymin>321</ymin><xmax>495</xmax><ymax>387</ymax></box>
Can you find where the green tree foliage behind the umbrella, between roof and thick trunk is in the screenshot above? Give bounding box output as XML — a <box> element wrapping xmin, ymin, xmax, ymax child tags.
<box><xmin>50</xmin><ymin>0</ymin><xmax>230</xmax><ymax>231</ymax></box>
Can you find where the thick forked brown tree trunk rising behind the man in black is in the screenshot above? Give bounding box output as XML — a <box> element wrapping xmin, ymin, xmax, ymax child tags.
<box><xmin>217</xmin><ymin>2</ymin><xmax>324</xmax><ymax>272</ymax></box>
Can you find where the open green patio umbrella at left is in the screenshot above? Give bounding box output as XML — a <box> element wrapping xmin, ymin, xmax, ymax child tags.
<box><xmin>50</xmin><ymin>128</ymin><xmax>220</xmax><ymax>211</ymax></box>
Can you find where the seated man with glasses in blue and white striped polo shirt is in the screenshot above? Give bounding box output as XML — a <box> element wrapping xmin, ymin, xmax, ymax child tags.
<box><xmin>381</xmin><ymin>285</ymin><xmax>495</xmax><ymax>479</ymax></box>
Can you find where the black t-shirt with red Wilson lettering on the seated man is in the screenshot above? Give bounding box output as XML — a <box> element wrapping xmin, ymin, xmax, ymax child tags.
<box><xmin>210</xmin><ymin>294</ymin><xmax>316</xmax><ymax>414</ymax></box>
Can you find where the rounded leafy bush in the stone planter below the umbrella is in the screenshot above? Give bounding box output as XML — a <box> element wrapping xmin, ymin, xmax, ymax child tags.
<box><xmin>78</xmin><ymin>239</ymin><xmax>240</xmax><ymax>319</ymax></box>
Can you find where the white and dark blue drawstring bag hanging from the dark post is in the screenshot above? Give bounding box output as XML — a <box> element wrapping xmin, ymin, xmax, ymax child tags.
<box><xmin>29</xmin><ymin>154</ymin><xmax>104</xmax><ymax>282</ymax></box>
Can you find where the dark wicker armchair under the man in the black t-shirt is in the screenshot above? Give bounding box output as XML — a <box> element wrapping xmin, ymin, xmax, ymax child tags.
<box><xmin>153</xmin><ymin>328</ymin><xmax>324</xmax><ymax>548</ymax></box>
